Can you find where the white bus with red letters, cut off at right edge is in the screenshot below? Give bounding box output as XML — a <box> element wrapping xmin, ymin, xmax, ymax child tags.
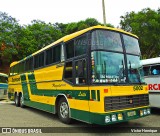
<box><xmin>141</xmin><ymin>57</ymin><xmax>160</xmax><ymax>108</ymax></box>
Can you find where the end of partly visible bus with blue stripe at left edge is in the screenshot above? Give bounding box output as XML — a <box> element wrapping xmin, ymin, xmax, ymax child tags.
<box><xmin>0</xmin><ymin>73</ymin><xmax>8</xmax><ymax>100</ymax></box>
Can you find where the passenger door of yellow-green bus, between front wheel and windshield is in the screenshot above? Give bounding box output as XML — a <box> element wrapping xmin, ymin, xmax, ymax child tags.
<box><xmin>73</xmin><ymin>58</ymin><xmax>89</xmax><ymax>122</ymax></box>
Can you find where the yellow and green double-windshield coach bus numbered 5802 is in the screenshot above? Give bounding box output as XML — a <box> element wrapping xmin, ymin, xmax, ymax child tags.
<box><xmin>8</xmin><ymin>26</ymin><xmax>150</xmax><ymax>125</ymax></box>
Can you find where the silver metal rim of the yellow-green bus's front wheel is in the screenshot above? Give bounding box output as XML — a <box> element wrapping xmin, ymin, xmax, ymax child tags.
<box><xmin>60</xmin><ymin>102</ymin><xmax>69</xmax><ymax>118</ymax></box>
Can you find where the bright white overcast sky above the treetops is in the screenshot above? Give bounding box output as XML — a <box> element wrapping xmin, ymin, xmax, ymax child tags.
<box><xmin>0</xmin><ymin>0</ymin><xmax>160</xmax><ymax>27</ymax></box>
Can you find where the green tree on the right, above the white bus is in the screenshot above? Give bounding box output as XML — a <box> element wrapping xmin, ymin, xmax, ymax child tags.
<box><xmin>120</xmin><ymin>8</ymin><xmax>160</xmax><ymax>58</ymax></box>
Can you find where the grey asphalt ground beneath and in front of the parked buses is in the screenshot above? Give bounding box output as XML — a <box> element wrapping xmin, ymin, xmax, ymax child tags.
<box><xmin>0</xmin><ymin>100</ymin><xmax>160</xmax><ymax>136</ymax></box>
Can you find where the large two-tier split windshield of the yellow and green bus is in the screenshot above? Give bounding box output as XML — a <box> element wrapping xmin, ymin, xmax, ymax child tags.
<box><xmin>91</xmin><ymin>30</ymin><xmax>144</xmax><ymax>83</ymax></box>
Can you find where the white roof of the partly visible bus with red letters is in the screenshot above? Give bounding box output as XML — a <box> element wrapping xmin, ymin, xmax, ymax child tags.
<box><xmin>141</xmin><ymin>57</ymin><xmax>160</xmax><ymax>66</ymax></box>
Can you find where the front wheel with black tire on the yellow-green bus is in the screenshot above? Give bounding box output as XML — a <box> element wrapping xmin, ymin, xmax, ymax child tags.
<box><xmin>58</xmin><ymin>97</ymin><xmax>71</xmax><ymax>124</ymax></box>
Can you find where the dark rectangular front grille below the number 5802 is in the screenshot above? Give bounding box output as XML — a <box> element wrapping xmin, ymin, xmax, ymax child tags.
<box><xmin>104</xmin><ymin>94</ymin><xmax>149</xmax><ymax>111</ymax></box>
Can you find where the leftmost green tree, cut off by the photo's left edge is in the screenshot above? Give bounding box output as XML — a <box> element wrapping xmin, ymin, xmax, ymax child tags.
<box><xmin>0</xmin><ymin>12</ymin><xmax>19</xmax><ymax>64</ymax></box>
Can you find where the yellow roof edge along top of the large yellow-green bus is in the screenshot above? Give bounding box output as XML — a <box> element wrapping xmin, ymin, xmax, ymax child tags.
<box><xmin>10</xmin><ymin>25</ymin><xmax>138</xmax><ymax>67</ymax></box>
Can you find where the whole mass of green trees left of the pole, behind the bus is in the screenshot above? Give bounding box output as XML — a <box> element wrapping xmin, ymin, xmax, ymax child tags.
<box><xmin>0</xmin><ymin>12</ymin><xmax>113</xmax><ymax>66</ymax></box>
